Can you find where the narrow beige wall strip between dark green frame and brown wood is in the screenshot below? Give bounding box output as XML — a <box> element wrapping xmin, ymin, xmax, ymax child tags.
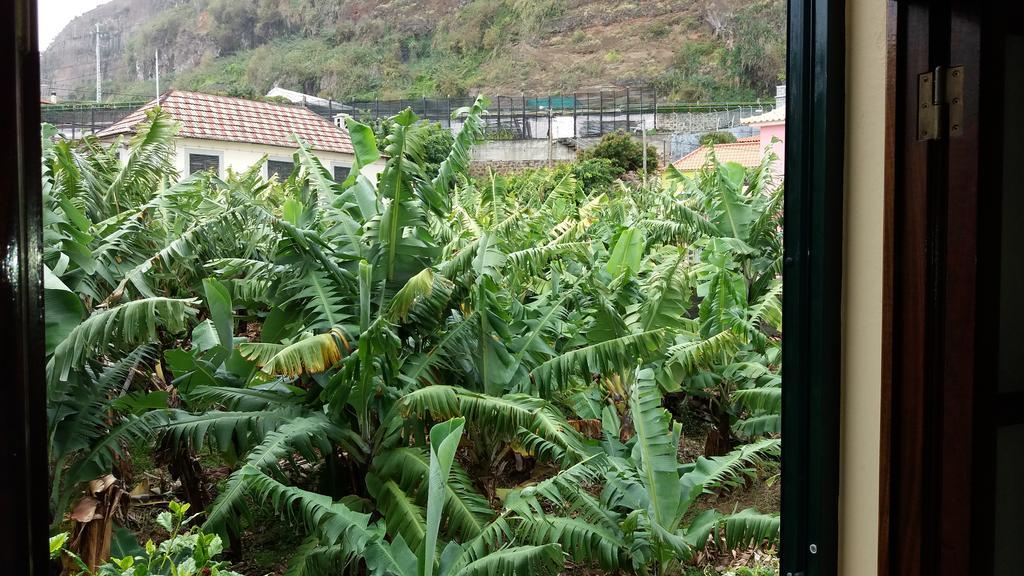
<box><xmin>840</xmin><ymin>0</ymin><xmax>887</xmax><ymax>576</ymax></box>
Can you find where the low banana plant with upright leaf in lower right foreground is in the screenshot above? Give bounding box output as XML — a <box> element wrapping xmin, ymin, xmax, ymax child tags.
<box><xmin>468</xmin><ymin>369</ymin><xmax>779</xmax><ymax>574</ymax></box>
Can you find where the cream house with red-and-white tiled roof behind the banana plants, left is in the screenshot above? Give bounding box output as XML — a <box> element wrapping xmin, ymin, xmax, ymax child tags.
<box><xmin>96</xmin><ymin>90</ymin><xmax>384</xmax><ymax>181</ymax></box>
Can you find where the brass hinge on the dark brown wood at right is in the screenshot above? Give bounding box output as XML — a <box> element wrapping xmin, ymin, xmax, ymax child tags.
<box><xmin>918</xmin><ymin>66</ymin><xmax>964</xmax><ymax>141</ymax></box>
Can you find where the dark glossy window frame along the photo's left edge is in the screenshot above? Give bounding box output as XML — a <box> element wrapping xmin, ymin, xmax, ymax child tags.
<box><xmin>6</xmin><ymin>0</ymin><xmax>49</xmax><ymax>576</ymax></box>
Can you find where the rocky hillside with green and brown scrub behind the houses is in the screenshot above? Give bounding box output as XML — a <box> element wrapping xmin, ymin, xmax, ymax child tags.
<box><xmin>36</xmin><ymin>0</ymin><xmax>785</xmax><ymax>100</ymax></box>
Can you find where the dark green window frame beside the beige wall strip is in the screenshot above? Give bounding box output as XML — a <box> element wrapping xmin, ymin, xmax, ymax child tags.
<box><xmin>779</xmin><ymin>0</ymin><xmax>843</xmax><ymax>576</ymax></box>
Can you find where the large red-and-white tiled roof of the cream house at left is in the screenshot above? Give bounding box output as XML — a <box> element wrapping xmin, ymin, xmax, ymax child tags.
<box><xmin>96</xmin><ymin>90</ymin><xmax>353</xmax><ymax>154</ymax></box>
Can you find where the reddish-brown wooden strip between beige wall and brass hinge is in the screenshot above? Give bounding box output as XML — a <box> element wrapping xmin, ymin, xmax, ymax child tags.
<box><xmin>882</xmin><ymin>3</ymin><xmax>931</xmax><ymax>576</ymax></box>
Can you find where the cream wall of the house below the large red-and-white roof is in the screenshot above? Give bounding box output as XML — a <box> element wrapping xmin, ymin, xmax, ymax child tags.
<box><xmin>175</xmin><ymin>138</ymin><xmax>384</xmax><ymax>176</ymax></box>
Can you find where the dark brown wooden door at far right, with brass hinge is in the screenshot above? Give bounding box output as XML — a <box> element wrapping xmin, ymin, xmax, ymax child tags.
<box><xmin>880</xmin><ymin>0</ymin><xmax>1024</xmax><ymax>576</ymax></box>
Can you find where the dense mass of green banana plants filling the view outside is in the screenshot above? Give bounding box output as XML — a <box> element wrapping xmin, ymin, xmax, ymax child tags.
<box><xmin>43</xmin><ymin>98</ymin><xmax>781</xmax><ymax>576</ymax></box>
